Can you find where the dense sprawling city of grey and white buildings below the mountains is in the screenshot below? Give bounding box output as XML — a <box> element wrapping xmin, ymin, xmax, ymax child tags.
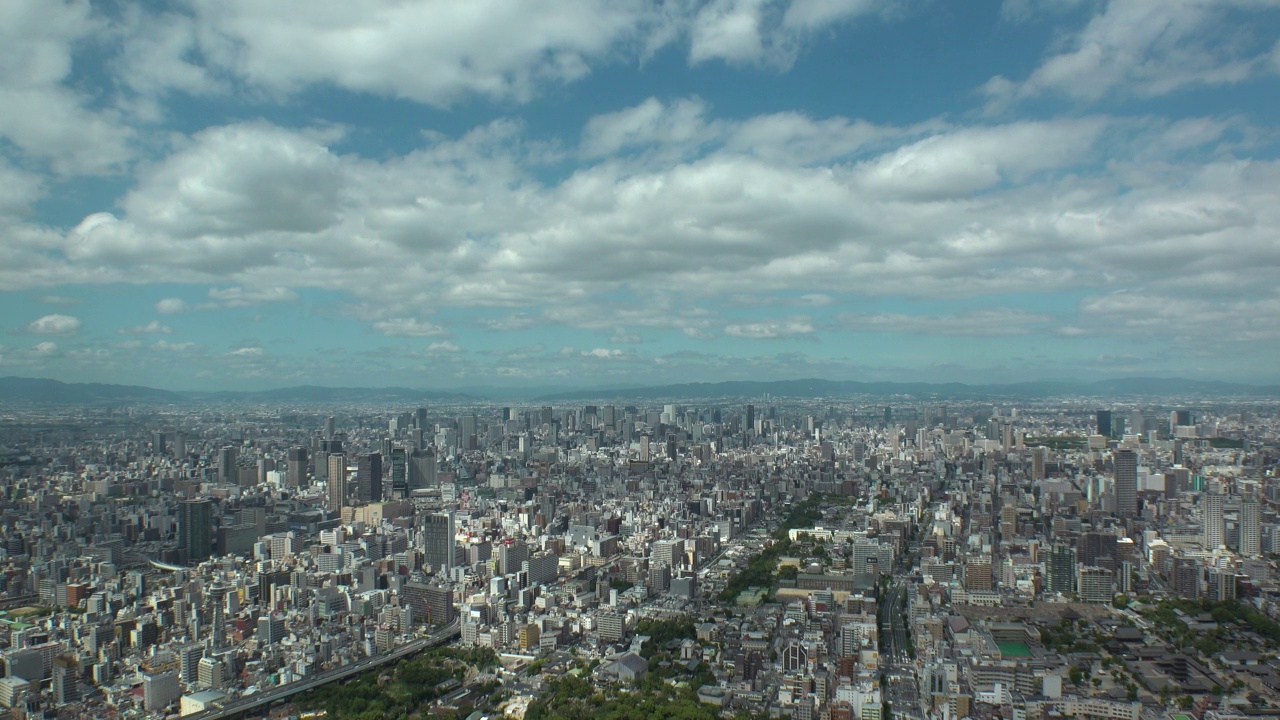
<box><xmin>0</xmin><ymin>386</ymin><xmax>1280</xmax><ymax>720</ymax></box>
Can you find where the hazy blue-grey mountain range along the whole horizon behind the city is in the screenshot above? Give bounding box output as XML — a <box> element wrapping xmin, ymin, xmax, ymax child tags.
<box><xmin>0</xmin><ymin>377</ymin><xmax>1280</xmax><ymax>405</ymax></box>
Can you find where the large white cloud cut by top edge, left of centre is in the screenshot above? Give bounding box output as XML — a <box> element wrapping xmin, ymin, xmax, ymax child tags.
<box><xmin>175</xmin><ymin>0</ymin><xmax>662</xmax><ymax>105</ymax></box>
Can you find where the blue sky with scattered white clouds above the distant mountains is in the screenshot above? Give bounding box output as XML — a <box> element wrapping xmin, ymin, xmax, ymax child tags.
<box><xmin>0</xmin><ymin>0</ymin><xmax>1280</xmax><ymax>389</ymax></box>
